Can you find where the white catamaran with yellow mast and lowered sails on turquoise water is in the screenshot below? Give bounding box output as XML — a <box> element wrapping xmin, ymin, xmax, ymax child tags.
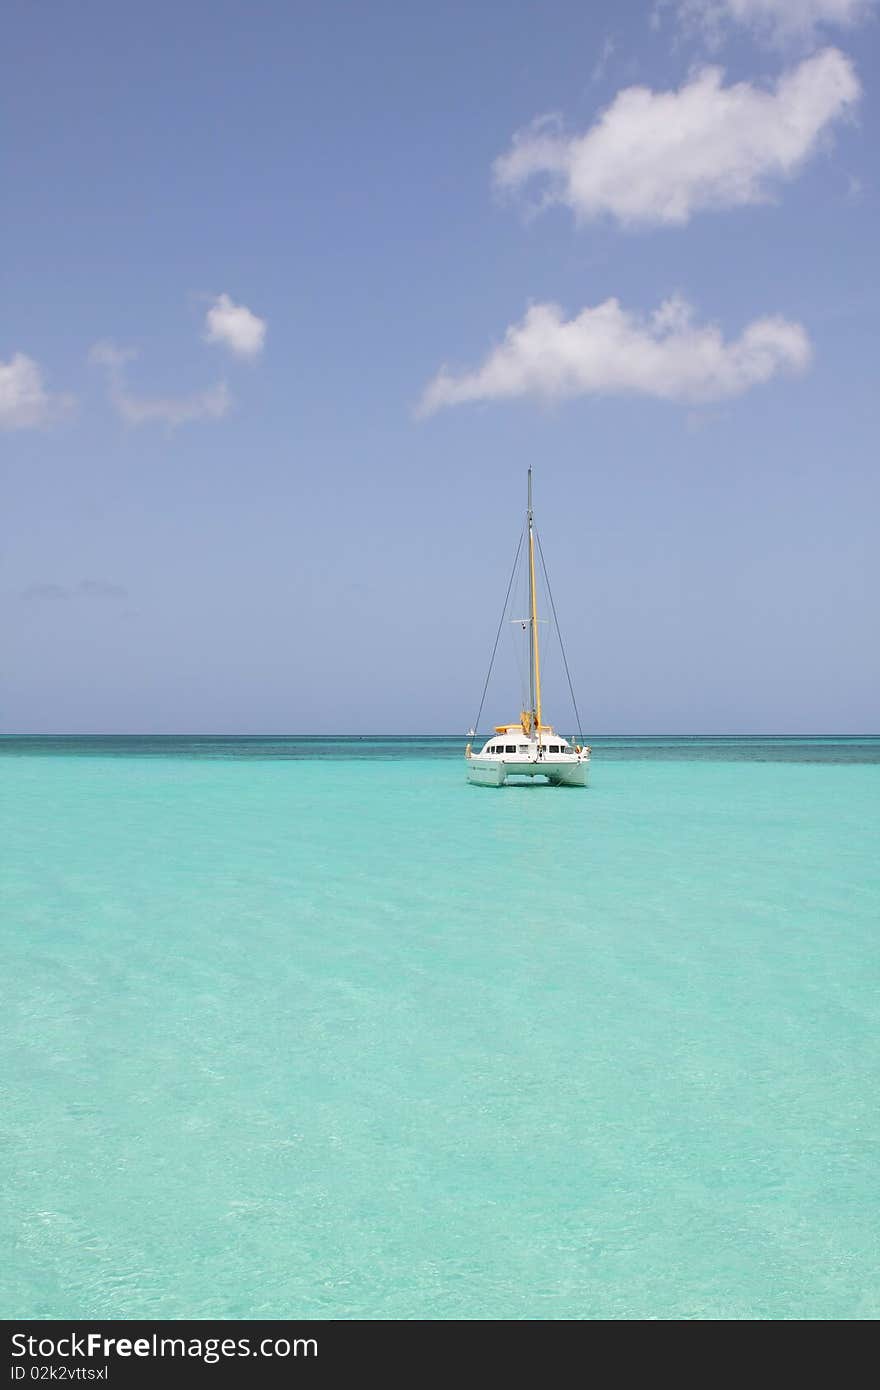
<box><xmin>464</xmin><ymin>468</ymin><xmax>591</xmax><ymax>787</ymax></box>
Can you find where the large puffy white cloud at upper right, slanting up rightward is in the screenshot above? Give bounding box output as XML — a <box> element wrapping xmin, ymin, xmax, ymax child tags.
<box><xmin>494</xmin><ymin>49</ymin><xmax>861</xmax><ymax>225</ymax></box>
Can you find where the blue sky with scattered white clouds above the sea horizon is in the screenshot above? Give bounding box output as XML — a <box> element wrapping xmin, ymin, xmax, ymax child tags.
<box><xmin>0</xmin><ymin>0</ymin><xmax>880</xmax><ymax>734</ymax></box>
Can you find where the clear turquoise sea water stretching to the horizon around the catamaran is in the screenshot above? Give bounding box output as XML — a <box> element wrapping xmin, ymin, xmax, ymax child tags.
<box><xmin>0</xmin><ymin>738</ymin><xmax>880</xmax><ymax>1319</ymax></box>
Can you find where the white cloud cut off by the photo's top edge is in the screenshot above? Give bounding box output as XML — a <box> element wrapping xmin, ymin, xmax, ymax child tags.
<box><xmin>674</xmin><ymin>0</ymin><xmax>877</xmax><ymax>47</ymax></box>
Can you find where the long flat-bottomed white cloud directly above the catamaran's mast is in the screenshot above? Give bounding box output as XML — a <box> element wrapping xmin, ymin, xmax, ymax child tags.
<box><xmin>418</xmin><ymin>297</ymin><xmax>812</xmax><ymax>414</ymax></box>
